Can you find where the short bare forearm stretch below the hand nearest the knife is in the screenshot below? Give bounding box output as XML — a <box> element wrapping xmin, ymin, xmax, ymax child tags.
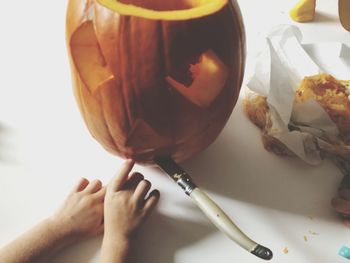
<box><xmin>101</xmin><ymin>235</ymin><xmax>133</xmax><ymax>263</ymax></box>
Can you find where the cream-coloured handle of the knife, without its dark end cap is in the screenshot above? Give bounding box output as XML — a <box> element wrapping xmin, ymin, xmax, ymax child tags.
<box><xmin>190</xmin><ymin>187</ymin><xmax>258</xmax><ymax>251</ymax></box>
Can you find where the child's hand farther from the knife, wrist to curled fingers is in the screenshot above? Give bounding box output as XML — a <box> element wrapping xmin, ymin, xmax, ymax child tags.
<box><xmin>50</xmin><ymin>178</ymin><xmax>106</xmax><ymax>240</ymax></box>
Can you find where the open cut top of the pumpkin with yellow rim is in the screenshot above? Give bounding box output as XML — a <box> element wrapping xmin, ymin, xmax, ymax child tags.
<box><xmin>97</xmin><ymin>0</ymin><xmax>228</xmax><ymax>20</ymax></box>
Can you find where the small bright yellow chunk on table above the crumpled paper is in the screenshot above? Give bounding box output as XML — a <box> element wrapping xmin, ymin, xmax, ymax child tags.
<box><xmin>289</xmin><ymin>0</ymin><xmax>316</xmax><ymax>22</ymax></box>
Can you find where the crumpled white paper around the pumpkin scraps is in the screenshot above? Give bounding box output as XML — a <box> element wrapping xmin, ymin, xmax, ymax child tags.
<box><xmin>247</xmin><ymin>25</ymin><xmax>350</xmax><ymax>168</ymax></box>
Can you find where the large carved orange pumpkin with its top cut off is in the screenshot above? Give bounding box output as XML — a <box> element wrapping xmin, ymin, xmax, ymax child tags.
<box><xmin>66</xmin><ymin>0</ymin><xmax>245</xmax><ymax>164</ymax></box>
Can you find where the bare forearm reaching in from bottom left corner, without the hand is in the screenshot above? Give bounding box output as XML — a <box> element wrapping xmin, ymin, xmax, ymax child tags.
<box><xmin>0</xmin><ymin>219</ymin><xmax>69</xmax><ymax>263</ymax></box>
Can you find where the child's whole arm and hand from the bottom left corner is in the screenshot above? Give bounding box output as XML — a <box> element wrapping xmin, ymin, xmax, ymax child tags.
<box><xmin>0</xmin><ymin>179</ymin><xmax>105</xmax><ymax>263</ymax></box>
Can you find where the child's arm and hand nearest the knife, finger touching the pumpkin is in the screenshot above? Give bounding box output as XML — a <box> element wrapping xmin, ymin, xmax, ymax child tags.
<box><xmin>101</xmin><ymin>160</ymin><xmax>159</xmax><ymax>263</ymax></box>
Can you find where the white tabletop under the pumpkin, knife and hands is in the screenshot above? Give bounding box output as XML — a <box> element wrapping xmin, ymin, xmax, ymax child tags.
<box><xmin>0</xmin><ymin>0</ymin><xmax>350</xmax><ymax>263</ymax></box>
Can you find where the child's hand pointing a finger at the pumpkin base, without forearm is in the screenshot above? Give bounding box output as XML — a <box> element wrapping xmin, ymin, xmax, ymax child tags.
<box><xmin>104</xmin><ymin>160</ymin><xmax>159</xmax><ymax>241</ymax></box>
